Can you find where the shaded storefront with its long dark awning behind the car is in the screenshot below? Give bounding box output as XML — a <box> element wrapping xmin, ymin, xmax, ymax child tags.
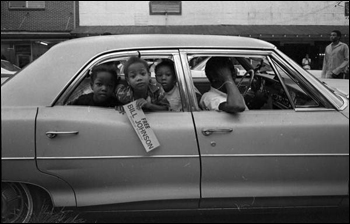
<box><xmin>72</xmin><ymin>25</ymin><xmax>349</xmax><ymax>69</ymax></box>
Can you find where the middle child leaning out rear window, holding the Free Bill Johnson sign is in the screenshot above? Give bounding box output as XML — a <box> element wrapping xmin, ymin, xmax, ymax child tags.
<box><xmin>117</xmin><ymin>56</ymin><xmax>169</xmax><ymax>111</ymax></box>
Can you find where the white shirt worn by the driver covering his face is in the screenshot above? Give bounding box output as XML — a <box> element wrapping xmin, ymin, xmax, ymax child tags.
<box><xmin>199</xmin><ymin>86</ymin><xmax>249</xmax><ymax>110</ymax></box>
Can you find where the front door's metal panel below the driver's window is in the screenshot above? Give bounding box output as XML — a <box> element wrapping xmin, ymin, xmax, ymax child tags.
<box><xmin>193</xmin><ymin>110</ymin><xmax>349</xmax><ymax>206</ymax></box>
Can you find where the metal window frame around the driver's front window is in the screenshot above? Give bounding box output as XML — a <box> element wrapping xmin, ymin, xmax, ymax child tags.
<box><xmin>180</xmin><ymin>49</ymin><xmax>335</xmax><ymax>111</ymax></box>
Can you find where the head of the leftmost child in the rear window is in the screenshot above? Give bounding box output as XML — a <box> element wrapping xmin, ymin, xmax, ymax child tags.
<box><xmin>91</xmin><ymin>72</ymin><xmax>115</xmax><ymax>103</ymax></box>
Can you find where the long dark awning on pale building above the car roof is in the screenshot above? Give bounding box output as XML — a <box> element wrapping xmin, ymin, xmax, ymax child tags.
<box><xmin>71</xmin><ymin>25</ymin><xmax>349</xmax><ymax>40</ymax></box>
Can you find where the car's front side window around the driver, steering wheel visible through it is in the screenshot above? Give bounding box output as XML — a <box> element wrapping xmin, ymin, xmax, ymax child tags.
<box><xmin>188</xmin><ymin>55</ymin><xmax>320</xmax><ymax>110</ymax></box>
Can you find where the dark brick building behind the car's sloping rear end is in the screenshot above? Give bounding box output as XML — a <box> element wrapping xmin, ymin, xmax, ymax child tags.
<box><xmin>1</xmin><ymin>1</ymin><xmax>76</xmax><ymax>67</ymax></box>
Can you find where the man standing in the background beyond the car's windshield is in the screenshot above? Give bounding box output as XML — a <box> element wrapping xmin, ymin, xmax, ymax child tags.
<box><xmin>321</xmin><ymin>30</ymin><xmax>349</xmax><ymax>79</ymax></box>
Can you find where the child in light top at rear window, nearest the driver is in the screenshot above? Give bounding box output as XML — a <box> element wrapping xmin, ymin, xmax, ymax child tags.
<box><xmin>155</xmin><ymin>59</ymin><xmax>182</xmax><ymax>111</ymax></box>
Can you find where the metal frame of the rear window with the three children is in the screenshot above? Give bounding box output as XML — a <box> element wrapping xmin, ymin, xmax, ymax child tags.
<box><xmin>53</xmin><ymin>49</ymin><xmax>190</xmax><ymax>112</ymax></box>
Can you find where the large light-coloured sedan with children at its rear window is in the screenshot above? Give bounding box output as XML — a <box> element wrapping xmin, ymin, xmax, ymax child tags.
<box><xmin>1</xmin><ymin>35</ymin><xmax>349</xmax><ymax>222</ymax></box>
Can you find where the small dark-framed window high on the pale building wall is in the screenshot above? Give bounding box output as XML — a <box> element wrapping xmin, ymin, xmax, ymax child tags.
<box><xmin>149</xmin><ymin>1</ymin><xmax>181</xmax><ymax>15</ymax></box>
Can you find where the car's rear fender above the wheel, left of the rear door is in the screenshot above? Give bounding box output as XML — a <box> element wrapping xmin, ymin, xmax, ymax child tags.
<box><xmin>1</xmin><ymin>107</ymin><xmax>76</xmax><ymax>206</ymax></box>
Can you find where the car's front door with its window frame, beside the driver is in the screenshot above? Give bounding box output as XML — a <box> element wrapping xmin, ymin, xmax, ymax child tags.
<box><xmin>181</xmin><ymin>50</ymin><xmax>349</xmax><ymax>209</ymax></box>
